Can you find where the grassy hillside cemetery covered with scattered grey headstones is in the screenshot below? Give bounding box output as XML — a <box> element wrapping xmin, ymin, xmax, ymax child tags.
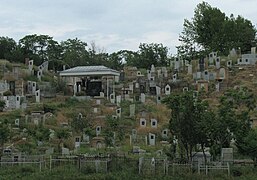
<box><xmin>0</xmin><ymin>45</ymin><xmax>257</xmax><ymax>180</ymax></box>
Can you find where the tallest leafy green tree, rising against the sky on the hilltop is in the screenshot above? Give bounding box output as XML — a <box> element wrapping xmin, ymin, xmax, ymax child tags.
<box><xmin>178</xmin><ymin>2</ymin><xmax>256</xmax><ymax>55</ymax></box>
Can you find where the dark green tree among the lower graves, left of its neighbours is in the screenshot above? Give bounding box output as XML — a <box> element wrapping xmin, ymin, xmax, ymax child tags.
<box><xmin>163</xmin><ymin>91</ymin><xmax>210</xmax><ymax>160</ymax></box>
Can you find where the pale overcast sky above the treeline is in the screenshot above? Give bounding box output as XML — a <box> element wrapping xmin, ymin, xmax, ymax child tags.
<box><xmin>0</xmin><ymin>0</ymin><xmax>257</xmax><ymax>54</ymax></box>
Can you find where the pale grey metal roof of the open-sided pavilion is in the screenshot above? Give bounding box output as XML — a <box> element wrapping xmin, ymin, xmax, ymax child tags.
<box><xmin>60</xmin><ymin>66</ymin><xmax>120</xmax><ymax>76</ymax></box>
